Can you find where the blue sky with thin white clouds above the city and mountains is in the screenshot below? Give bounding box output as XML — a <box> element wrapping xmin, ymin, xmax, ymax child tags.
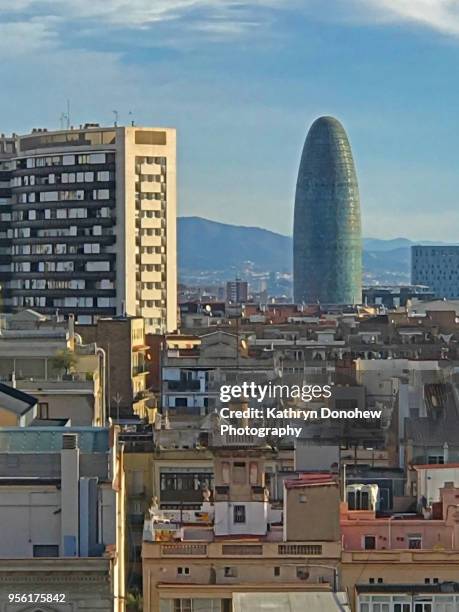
<box><xmin>0</xmin><ymin>0</ymin><xmax>459</xmax><ymax>242</ymax></box>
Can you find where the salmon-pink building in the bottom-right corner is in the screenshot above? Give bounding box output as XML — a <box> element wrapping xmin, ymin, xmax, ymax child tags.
<box><xmin>341</xmin><ymin>483</ymin><xmax>459</xmax><ymax>612</ymax></box>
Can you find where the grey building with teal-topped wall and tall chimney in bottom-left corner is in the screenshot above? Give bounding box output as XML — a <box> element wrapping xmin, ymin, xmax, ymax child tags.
<box><xmin>0</xmin><ymin>427</ymin><xmax>125</xmax><ymax>612</ymax></box>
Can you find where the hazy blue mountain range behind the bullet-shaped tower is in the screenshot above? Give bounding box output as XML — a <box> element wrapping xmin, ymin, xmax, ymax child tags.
<box><xmin>177</xmin><ymin>217</ymin><xmax>444</xmax><ymax>284</ymax></box>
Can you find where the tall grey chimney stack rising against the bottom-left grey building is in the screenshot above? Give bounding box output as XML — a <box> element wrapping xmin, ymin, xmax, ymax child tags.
<box><xmin>60</xmin><ymin>433</ymin><xmax>80</xmax><ymax>557</ymax></box>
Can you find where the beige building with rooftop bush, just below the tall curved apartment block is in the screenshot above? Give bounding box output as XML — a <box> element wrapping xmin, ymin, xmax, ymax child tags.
<box><xmin>0</xmin><ymin>309</ymin><xmax>107</xmax><ymax>426</ymax></box>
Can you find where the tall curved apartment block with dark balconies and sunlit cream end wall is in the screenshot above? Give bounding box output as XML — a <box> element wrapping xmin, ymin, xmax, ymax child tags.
<box><xmin>0</xmin><ymin>124</ymin><xmax>177</xmax><ymax>332</ymax></box>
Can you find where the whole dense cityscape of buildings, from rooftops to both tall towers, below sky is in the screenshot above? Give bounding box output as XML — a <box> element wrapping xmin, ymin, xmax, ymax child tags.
<box><xmin>0</xmin><ymin>117</ymin><xmax>459</xmax><ymax>612</ymax></box>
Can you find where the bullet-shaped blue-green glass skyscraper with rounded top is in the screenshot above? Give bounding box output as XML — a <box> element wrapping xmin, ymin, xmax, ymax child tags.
<box><xmin>293</xmin><ymin>117</ymin><xmax>362</xmax><ymax>304</ymax></box>
